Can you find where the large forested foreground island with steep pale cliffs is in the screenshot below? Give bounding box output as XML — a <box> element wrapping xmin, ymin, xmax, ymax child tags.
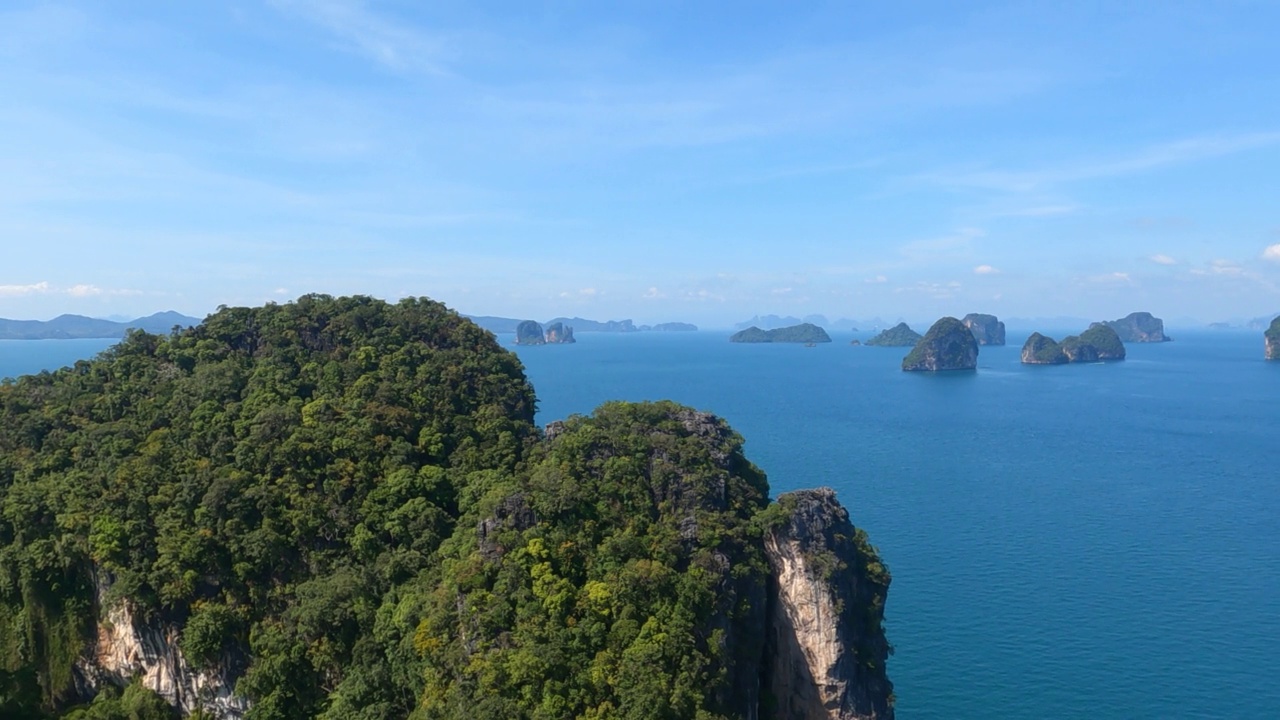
<box><xmin>0</xmin><ymin>296</ymin><xmax>893</xmax><ymax>720</ymax></box>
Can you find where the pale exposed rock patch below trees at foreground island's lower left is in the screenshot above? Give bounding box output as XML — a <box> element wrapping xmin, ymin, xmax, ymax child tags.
<box><xmin>76</xmin><ymin>579</ymin><xmax>250</xmax><ymax>720</ymax></box>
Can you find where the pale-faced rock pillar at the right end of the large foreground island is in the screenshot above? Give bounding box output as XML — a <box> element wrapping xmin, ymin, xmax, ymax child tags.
<box><xmin>762</xmin><ymin>488</ymin><xmax>893</xmax><ymax>720</ymax></box>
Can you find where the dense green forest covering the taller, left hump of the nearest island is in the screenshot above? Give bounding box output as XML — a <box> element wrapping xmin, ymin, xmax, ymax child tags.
<box><xmin>0</xmin><ymin>296</ymin><xmax>535</xmax><ymax>719</ymax></box>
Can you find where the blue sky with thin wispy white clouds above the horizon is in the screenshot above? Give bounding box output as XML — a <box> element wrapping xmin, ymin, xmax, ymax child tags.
<box><xmin>0</xmin><ymin>0</ymin><xmax>1280</xmax><ymax>325</ymax></box>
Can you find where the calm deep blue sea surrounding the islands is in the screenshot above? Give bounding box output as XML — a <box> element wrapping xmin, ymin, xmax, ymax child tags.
<box><xmin>0</xmin><ymin>328</ymin><xmax>1280</xmax><ymax>720</ymax></box>
